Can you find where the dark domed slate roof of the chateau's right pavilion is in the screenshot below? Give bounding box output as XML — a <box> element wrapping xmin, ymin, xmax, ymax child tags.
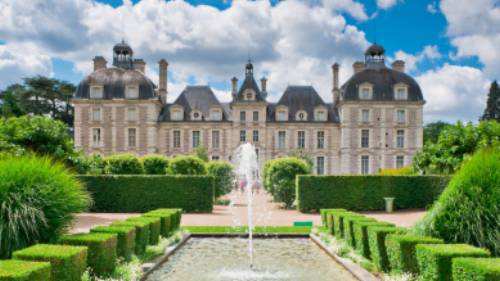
<box><xmin>341</xmin><ymin>66</ymin><xmax>424</xmax><ymax>101</ymax></box>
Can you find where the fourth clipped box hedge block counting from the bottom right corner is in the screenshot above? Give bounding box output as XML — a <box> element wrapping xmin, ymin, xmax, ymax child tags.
<box><xmin>367</xmin><ymin>225</ymin><xmax>403</xmax><ymax>272</ymax></box>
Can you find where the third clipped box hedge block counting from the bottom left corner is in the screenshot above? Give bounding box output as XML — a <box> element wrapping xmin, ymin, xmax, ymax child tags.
<box><xmin>60</xmin><ymin>233</ymin><xmax>117</xmax><ymax>276</ymax></box>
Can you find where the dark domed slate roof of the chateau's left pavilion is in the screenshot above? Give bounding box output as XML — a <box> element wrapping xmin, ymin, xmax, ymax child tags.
<box><xmin>75</xmin><ymin>67</ymin><xmax>158</xmax><ymax>99</ymax></box>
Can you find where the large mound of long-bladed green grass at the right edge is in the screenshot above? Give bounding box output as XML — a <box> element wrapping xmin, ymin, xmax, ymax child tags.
<box><xmin>415</xmin><ymin>149</ymin><xmax>500</xmax><ymax>255</ymax></box>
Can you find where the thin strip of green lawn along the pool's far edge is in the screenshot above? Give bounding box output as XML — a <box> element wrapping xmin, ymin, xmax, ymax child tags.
<box><xmin>181</xmin><ymin>226</ymin><xmax>312</xmax><ymax>234</ymax></box>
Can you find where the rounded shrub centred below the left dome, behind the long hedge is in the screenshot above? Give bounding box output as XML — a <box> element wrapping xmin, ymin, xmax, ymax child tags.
<box><xmin>104</xmin><ymin>154</ymin><xmax>144</xmax><ymax>175</ymax></box>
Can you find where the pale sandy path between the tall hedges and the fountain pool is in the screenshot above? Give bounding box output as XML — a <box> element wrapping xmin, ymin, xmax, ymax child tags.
<box><xmin>70</xmin><ymin>192</ymin><xmax>425</xmax><ymax>233</ymax></box>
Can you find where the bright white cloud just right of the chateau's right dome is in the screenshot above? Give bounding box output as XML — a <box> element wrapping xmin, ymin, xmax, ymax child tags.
<box><xmin>416</xmin><ymin>64</ymin><xmax>489</xmax><ymax>122</ymax></box>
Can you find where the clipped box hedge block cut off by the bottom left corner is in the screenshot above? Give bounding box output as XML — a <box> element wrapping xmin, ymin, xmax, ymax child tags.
<box><xmin>0</xmin><ymin>260</ymin><xmax>51</xmax><ymax>281</ymax></box>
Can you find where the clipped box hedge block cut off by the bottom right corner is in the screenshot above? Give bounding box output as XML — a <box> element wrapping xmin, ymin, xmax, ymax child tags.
<box><xmin>452</xmin><ymin>258</ymin><xmax>500</xmax><ymax>281</ymax></box>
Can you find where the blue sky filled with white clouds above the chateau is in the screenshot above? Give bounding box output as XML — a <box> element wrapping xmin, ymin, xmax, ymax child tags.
<box><xmin>0</xmin><ymin>0</ymin><xmax>500</xmax><ymax>122</ymax></box>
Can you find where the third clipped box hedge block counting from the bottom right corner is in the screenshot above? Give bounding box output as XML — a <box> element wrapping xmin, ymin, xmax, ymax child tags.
<box><xmin>386</xmin><ymin>234</ymin><xmax>443</xmax><ymax>274</ymax></box>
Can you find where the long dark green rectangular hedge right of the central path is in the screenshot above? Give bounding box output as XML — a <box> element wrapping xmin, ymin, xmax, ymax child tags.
<box><xmin>297</xmin><ymin>175</ymin><xmax>449</xmax><ymax>212</ymax></box>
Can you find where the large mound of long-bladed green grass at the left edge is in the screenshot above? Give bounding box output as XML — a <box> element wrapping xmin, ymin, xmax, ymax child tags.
<box><xmin>0</xmin><ymin>156</ymin><xmax>91</xmax><ymax>258</ymax></box>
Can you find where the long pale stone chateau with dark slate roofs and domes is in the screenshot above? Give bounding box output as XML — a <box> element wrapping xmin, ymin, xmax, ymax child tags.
<box><xmin>73</xmin><ymin>42</ymin><xmax>425</xmax><ymax>174</ymax></box>
